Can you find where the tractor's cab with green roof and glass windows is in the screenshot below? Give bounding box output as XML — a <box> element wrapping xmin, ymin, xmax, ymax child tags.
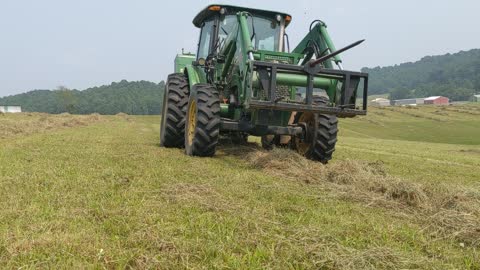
<box><xmin>193</xmin><ymin>5</ymin><xmax>291</xmax><ymax>59</ymax></box>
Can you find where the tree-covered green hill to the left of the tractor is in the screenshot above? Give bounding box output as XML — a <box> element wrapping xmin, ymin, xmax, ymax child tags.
<box><xmin>0</xmin><ymin>80</ymin><xmax>164</xmax><ymax>114</ymax></box>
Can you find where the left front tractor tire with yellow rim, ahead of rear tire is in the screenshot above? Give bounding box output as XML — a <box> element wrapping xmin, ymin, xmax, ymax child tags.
<box><xmin>185</xmin><ymin>84</ymin><xmax>220</xmax><ymax>157</ymax></box>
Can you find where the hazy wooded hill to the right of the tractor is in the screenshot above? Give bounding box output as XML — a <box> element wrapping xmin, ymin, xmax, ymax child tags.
<box><xmin>362</xmin><ymin>49</ymin><xmax>480</xmax><ymax>100</ymax></box>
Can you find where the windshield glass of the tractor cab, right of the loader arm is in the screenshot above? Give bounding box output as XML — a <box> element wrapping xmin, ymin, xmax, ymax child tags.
<box><xmin>248</xmin><ymin>17</ymin><xmax>280</xmax><ymax>51</ymax></box>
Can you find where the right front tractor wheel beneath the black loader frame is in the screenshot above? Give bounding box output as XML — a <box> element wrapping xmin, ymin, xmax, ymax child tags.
<box><xmin>292</xmin><ymin>97</ymin><xmax>338</xmax><ymax>164</ymax></box>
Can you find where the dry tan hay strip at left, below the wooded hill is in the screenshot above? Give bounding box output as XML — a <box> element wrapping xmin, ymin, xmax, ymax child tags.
<box><xmin>0</xmin><ymin>113</ymin><xmax>103</xmax><ymax>139</ymax></box>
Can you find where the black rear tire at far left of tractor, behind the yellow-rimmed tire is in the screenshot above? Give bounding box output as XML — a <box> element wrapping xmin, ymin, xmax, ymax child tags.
<box><xmin>160</xmin><ymin>73</ymin><xmax>189</xmax><ymax>148</ymax></box>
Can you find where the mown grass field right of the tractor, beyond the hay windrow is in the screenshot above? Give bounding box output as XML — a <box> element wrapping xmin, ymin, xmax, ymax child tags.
<box><xmin>335</xmin><ymin>104</ymin><xmax>480</xmax><ymax>188</ymax></box>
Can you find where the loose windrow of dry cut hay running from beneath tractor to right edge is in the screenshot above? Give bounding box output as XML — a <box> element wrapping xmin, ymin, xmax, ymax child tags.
<box><xmin>230</xmin><ymin>147</ymin><xmax>480</xmax><ymax>246</ymax></box>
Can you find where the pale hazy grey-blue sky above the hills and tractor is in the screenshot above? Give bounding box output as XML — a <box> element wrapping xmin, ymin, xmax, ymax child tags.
<box><xmin>0</xmin><ymin>0</ymin><xmax>480</xmax><ymax>97</ymax></box>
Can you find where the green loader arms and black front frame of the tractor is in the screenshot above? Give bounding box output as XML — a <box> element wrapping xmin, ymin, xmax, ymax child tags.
<box><xmin>219</xmin><ymin>12</ymin><xmax>368</xmax><ymax>116</ymax></box>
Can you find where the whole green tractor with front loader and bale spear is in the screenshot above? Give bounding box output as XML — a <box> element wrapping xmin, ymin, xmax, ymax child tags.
<box><xmin>160</xmin><ymin>5</ymin><xmax>368</xmax><ymax>163</ymax></box>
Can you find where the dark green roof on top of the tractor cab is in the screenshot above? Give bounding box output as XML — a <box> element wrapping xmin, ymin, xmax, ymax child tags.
<box><xmin>193</xmin><ymin>4</ymin><xmax>292</xmax><ymax>27</ymax></box>
